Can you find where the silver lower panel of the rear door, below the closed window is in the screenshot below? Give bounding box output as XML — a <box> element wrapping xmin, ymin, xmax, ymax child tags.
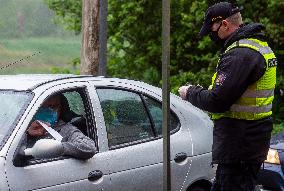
<box><xmin>106</xmin><ymin>126</ymin><xmax>191</xmax><ymax>190</ymax></box>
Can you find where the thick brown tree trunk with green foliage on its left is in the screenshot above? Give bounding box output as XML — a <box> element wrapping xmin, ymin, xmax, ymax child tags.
<box><xmin>45</xmin><ymin>0</ymin><xmax>99</xmax><ymax>75</ymax></box>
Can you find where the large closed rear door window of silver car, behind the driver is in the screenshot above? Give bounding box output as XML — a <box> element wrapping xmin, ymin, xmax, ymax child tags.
<box><xmin>97</xmin><ymin>89</ymin><xmax>153</xmax><ymax>147</ymax></box>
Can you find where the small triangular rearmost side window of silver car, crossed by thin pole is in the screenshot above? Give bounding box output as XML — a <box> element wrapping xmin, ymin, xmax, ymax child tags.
<box><xmin>144</xmin><ymin>96</ymin><xmax>180</xmax><ymax>136</ymax></box>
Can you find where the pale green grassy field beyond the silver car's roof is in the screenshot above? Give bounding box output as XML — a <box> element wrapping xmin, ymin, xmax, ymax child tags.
<box><xmin>0</xmin><ymin>37</ymin><xmax>81</xmax><ymax>74</ymax></box>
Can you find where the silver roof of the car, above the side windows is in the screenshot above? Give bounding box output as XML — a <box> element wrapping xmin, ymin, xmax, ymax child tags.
<box><xmin>0</xmin><ymin>74</ymin><xmax>158</xmax><ymax>92</ymax></box>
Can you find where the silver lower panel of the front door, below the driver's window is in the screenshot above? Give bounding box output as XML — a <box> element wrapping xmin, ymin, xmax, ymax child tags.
<box><xmin>6</xmin><ymin>154</ymin><xmax>109</xmax><ymax>191</ymax></box>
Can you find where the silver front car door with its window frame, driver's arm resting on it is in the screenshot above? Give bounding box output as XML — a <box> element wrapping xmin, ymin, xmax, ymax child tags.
<box><xmin>5</xmin><ymin>82</ymin><xmax>109</xmax><ymax>191</ymax></box>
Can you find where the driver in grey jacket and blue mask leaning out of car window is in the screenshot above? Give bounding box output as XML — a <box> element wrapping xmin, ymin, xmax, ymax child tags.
<box><xmin>27</xmin><ymin>95</ymin><xmax>96</xmax><ymax>159</ymax></box>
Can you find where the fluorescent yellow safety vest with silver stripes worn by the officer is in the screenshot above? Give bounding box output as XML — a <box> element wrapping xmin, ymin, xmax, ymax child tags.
<box><xmin>211</xmin><ymin>38</ymin><xmax>277</xmax><ymax>120</ymax></box>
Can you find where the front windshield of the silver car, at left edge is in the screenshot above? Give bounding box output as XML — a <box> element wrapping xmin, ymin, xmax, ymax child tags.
<box><xmin>0</xmin><ymin>91</ymin><xmax>32</xmax><ymax>145</ymax></box>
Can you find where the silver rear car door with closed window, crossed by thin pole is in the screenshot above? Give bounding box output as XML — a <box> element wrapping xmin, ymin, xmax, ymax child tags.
<box><xmin>96</xmin><ymin>86</ymin><xmax>191</xmax><ymax>191</ymax></box>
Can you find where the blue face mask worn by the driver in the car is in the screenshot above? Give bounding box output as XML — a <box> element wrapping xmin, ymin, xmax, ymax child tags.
<box><xmin>32</xmin><ymin>107</ymin><xmax>58</xmax><ymax>127</ymax></box>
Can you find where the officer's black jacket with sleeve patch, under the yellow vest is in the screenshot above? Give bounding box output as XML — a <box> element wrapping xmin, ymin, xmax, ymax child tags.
<box><xmin>187</xmin><ymin>24</ymin><xmax>272</xmax><ymax>163</ymax></box>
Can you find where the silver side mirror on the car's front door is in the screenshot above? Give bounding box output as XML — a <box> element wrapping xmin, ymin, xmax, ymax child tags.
<box><xmin>24</xmin><ymin>139</ymin><xmax>63</xmax><ymax>159</ymax></box>
